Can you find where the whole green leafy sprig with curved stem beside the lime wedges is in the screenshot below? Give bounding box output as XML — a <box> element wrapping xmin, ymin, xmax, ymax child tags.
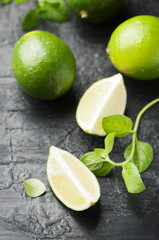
<box><xmin>81</xmin><ymin>98</ymin><xmax>159</xmax><ymax>193</ymax></box>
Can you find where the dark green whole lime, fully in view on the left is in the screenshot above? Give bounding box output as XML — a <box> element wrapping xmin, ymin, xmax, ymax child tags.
<box><xmin>12</xmin><ymin>31</ymin><xmax>76</xmax><ymax>100</ymax></box>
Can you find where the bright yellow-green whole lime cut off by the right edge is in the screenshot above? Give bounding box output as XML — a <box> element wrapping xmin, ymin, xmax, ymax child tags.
<box><xmin>106</xmin><ymin>15</ymin><xmax>159</xmax><ymax>80</ymax></box>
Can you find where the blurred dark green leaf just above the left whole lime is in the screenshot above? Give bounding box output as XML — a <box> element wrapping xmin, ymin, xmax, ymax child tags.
<box><xmin>22</xmin><ymin>9</ymin><xmax>39</xmax><ymax>30</ymax></box>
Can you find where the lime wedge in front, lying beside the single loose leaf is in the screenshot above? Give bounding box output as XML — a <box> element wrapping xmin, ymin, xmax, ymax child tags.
<box><xmin>47</xmin><ymin>146</ymin><xmax>100</xmax><ymax>211</ymax></box>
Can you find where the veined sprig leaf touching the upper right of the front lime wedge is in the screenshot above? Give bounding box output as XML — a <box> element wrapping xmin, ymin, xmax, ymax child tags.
<box><xmin>80</xmin><ymin>152</ymin><xmax>114</xmax><ymax>177</ymax></box>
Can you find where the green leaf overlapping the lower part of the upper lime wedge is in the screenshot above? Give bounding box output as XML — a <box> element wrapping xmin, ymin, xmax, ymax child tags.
<box><xmin>102</xmin><ymin>114</ymin><xmax>133</xmax><ymax>137</ymax></box>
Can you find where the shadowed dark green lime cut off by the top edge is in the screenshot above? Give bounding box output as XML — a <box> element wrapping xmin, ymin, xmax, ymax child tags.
<box><xmin>67</xmin><ymin>0</ymin><xmax>124</xmax><ymax>23</ymax></box>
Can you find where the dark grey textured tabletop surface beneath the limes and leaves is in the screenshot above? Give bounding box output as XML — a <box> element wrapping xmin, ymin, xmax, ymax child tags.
<box><xmin>0</xmin><ymin>0</ymin><xmax>159</xmax><ymax>240</ymax></box>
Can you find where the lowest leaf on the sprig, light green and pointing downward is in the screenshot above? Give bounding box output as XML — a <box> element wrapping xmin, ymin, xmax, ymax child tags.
<box><xmin>122</xmin><ymin>163</ymin><xmax>145</xmax><ymax>193</ymax></box>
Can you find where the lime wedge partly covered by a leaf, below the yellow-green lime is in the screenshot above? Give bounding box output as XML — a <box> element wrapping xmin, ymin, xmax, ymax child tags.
<box><xmin>76</xmin><ymin>73</ymin><xmax>127</xmax><ymax>136</ymax></box>
